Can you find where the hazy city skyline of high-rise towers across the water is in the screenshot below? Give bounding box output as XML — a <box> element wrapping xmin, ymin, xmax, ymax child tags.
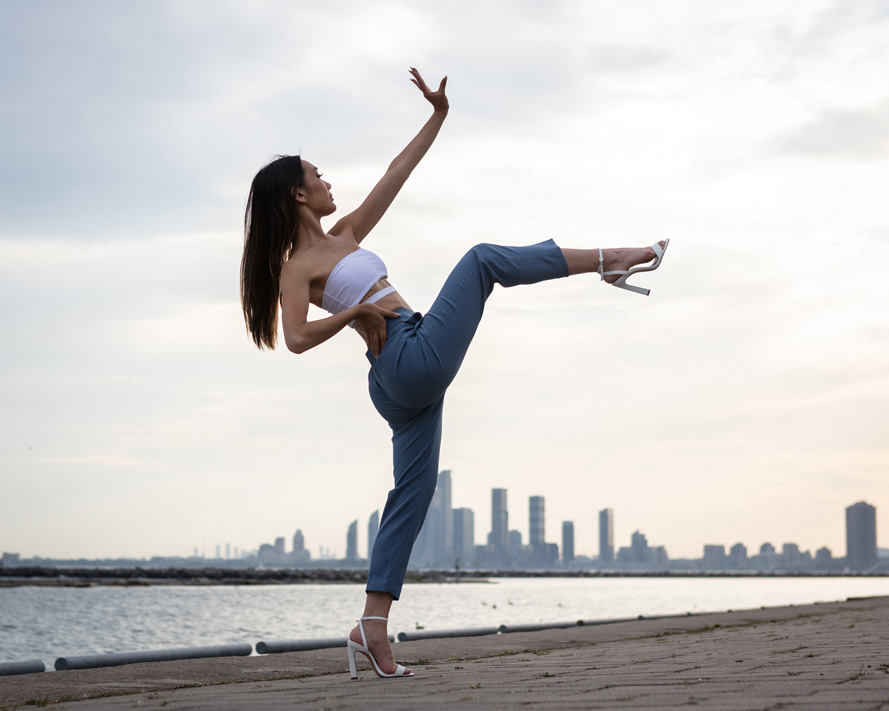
<box><xmin>34</xmin><ymin>484</ymin><xmax>868</xmax><ymax>571</ymax></box>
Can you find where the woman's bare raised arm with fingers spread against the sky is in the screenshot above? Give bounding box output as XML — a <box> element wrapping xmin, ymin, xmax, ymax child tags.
<box><xmin>331</xmin><ymin>67</ymin><xmax>448</xmax><ymax>242</ymax></box>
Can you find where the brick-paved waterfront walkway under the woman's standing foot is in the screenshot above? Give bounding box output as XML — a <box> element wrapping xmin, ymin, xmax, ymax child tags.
<box><xmin>0</xmin><ymin>597</ymin><xmax>889</xmax><ymax>711</ymax></box>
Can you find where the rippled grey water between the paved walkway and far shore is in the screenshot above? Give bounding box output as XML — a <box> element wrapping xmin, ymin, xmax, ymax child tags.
<box><xmin>0</xmin><ymin>578</ymin><xmax>889</xmax><ymax>669</ymax></box>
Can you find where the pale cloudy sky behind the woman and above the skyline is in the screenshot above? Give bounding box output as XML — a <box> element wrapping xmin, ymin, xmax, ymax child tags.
<box><xmin>0</xmin><ymin>0</ymin><xmax>889</xmax><ymax>558</ymax></box>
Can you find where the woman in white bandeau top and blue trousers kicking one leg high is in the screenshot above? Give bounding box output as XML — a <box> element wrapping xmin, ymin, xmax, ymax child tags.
<box><xmin>241</xmin><ymin>68</ymin><xmax>669</xmax><ymax>678</ymax></box>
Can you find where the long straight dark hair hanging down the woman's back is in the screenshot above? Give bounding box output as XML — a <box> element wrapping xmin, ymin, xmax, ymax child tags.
<box><xmin>241</xmin><ymin>156</ymin><xmax>303</xmax><ymax>349</ymax></box>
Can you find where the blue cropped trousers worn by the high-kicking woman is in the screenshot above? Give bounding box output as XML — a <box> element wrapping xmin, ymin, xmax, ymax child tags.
<box><xmin>367</xmin><ymin>240</ymin><xmax>568</xmax><ymax>600</ymax></box>
